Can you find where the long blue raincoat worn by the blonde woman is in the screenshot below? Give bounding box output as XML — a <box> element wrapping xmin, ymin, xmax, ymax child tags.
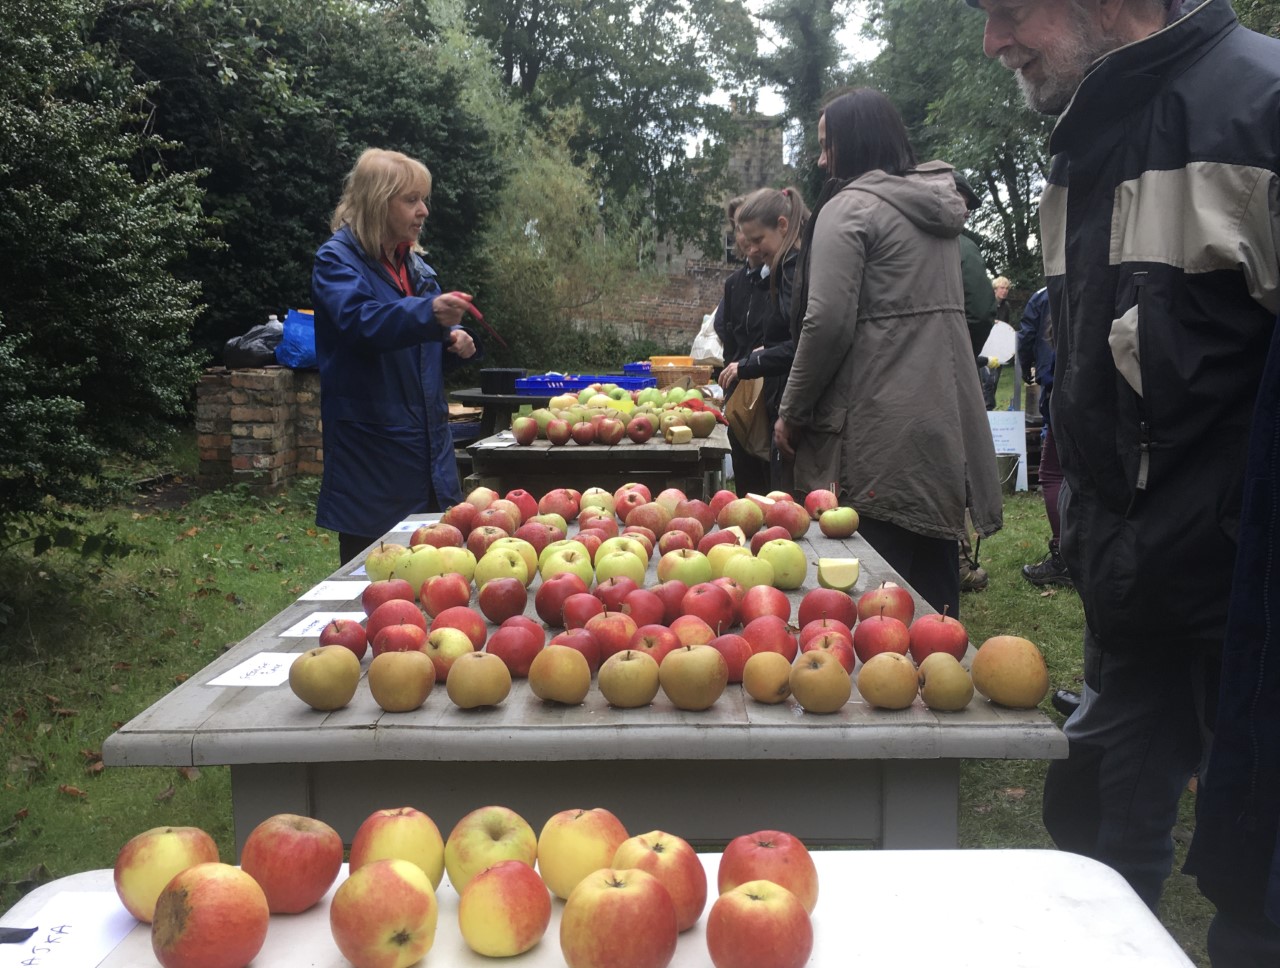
<box><xmin>311</xmin><ymin>227</ymin><xmax>481</xmax><ymax>538</ymax></box>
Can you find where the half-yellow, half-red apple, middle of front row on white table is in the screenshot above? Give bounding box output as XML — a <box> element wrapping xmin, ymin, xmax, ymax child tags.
<box><xmin>458</xmin><ymin>860</ymin><xmax>550</xmax><ymax>958</ymax></box>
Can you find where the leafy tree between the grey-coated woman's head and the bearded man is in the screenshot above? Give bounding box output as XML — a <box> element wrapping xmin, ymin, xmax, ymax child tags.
<box><xmin>865</xmin><ymin>0</ymin><xmax>1052</xmax><ymax>286</ymax></box>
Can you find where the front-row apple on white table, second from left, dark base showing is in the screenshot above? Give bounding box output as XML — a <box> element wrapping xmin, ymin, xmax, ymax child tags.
<box><xmin>329</xmin><ymin>859</ymin><xmax>440</xmax><ymax>968</ymax></box>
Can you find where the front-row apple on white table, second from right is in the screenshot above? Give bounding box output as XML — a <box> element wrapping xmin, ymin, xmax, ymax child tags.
<box><xmin>559</xmin><ymin>867</ymin><xmax>678</xmax><ymax>968</ymax></box>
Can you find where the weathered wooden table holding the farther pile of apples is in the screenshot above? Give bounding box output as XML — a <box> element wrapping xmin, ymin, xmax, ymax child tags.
<box><xmin>463</xmin><ymin>424</ymin><xmax>728</xmax><ymax>501</ymax></box>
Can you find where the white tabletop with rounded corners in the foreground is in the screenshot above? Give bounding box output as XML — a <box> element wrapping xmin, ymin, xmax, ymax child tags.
<box><xmin>0</xmin><ymin>850</ymin><xmax>1192</xmax><ymax>968</ymax></box>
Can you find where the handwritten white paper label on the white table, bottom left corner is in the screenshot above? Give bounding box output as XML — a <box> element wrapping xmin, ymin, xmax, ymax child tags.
<box><xmin>0</xmin><ymin>891</ymin><xmax>138</xmax><ymax>968</ymax></box>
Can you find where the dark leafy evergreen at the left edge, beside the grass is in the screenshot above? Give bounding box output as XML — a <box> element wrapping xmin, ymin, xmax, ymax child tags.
<box><xmin>0</xmin><ymin>0</ymin><xmax>206</xmax><ymax>551</ymax></box>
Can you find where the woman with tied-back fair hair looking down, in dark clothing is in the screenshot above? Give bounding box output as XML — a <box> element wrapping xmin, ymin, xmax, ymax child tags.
<box><xmin>721</xmin><ymin>188</ymin><xmax>809</xmax><ymax>493</ymax></box>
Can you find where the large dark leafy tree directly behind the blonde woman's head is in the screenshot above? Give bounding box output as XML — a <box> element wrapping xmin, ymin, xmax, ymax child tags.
<box><xmin>97</xmin><ymin>0</ymin><xmax>502</xmax><ymax>347</ymax></box>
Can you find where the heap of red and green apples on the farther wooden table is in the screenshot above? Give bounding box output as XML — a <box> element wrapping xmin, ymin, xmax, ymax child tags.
<box><xmin>511</xmin><ymin>383</ymin><xmax>719</xmax><ymax>447</ymax></box>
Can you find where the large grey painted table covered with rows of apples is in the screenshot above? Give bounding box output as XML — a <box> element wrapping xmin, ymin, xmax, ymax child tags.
<box><xmin>102</xmin><ymin>516</ymin><xmax>1066</xmax><ymax>848</ymax></box>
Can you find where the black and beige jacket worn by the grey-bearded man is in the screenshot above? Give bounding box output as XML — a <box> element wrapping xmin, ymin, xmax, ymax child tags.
<box><xmin>1041</xmin><ymin>0</ymin><xmax>1280</xmax><ymax>649</ymax></box>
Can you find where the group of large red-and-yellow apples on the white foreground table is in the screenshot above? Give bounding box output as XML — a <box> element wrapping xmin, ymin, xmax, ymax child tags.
<box><xmin>115</xmin><ymin>805</ymin><xmax>818</xmax><ymax>968</ymax></box>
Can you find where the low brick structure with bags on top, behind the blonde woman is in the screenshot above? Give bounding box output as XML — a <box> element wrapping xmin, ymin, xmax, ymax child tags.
<box><xmin>196</xmin><ymin>366</ymin><xmax>324</xmax><ymax>490</ymax></box>
